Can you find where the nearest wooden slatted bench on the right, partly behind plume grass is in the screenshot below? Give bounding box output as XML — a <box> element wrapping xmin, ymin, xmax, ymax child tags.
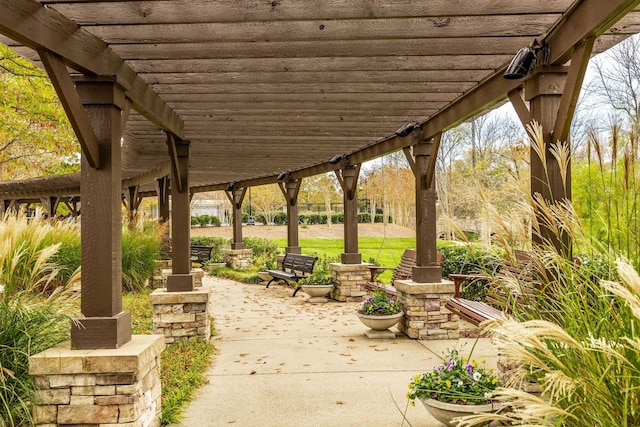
<box><xmin>445</xmin><ymin>251</ymin><xmax>539</xmax><ymax>326</ymax></box>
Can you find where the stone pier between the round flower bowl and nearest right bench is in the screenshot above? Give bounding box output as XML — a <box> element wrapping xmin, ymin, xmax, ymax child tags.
<box><xmin>394</xmin><ymin>280</ymin><xmax>460</xmax><ymax>340</ymax></box>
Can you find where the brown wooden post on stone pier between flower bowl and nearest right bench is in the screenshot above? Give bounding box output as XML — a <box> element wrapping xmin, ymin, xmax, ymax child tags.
<box><xmin>404</xmin><ymin>134</ymin><xmax>442</xmax><ymax>283</ymax></box>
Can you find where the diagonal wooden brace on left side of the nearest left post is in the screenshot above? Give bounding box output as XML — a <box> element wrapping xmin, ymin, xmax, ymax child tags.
<box><xmin>38</xmin><ymin>49</ymin><xmax>100</xmax><ymax>169</ymax></box>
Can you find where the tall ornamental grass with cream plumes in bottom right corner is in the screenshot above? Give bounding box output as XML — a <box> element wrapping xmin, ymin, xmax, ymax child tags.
<box><xmin>459</xmin><ymin>122</ymin><xmax>640</xmax><ymax>427</ymax></box>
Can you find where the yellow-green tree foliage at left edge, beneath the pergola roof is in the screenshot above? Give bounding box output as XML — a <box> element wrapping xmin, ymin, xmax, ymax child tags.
<box><xmin>0</xmin><ymin>44</ymin><xmax>79</xmax><ymax>180</ymax></box>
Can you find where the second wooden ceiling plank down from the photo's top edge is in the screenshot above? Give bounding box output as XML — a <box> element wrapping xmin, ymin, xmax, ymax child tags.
<box><xmin>85</xmin><ymin>14</ymin><xmax>561</xmax><ymax>44</ymax></box>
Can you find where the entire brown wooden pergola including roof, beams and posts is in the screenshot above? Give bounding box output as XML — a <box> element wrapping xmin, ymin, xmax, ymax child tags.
<box><xmin>0</xmin><ymin>0</ymin><xmax>640</xmax><ymax>348</ymax></box>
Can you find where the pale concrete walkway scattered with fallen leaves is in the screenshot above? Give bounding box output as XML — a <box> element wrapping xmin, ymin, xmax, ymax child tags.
<box><xmin>171</xmin><ymin>277</ymin><xmax>495</xmax><ymax>427</ymax></box>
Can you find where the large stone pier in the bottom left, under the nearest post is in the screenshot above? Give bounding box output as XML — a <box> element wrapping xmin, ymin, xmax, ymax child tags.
<box><xmin>29</xmin><ymin>335</ymin><xmax>165</xmax><ymax>427</ymax></box>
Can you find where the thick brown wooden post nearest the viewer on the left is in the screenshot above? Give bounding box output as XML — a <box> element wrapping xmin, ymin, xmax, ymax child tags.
<box><xmin>71</xmin><ymin>77</ymin><xmax>131</xmax><ymax>349</ymax></box>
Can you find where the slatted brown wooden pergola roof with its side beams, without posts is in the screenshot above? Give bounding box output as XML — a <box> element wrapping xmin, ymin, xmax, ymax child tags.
<box><xmin>0</xmin><ymin>0</ymin><xmax>640</xmax><ymax>198</ymax></box>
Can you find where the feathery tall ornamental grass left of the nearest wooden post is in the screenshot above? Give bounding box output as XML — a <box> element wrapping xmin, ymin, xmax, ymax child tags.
<box><xmin>0</xmin><ymin>214</ymin><xmax>79</xmax><ymax>427</ymax></box>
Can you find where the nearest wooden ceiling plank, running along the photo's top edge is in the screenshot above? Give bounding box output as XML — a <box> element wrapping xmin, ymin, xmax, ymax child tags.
<box><xmin>41</xmin><ymin>0</ymin><xmax>573</xmax><ymax>25</ymax></box>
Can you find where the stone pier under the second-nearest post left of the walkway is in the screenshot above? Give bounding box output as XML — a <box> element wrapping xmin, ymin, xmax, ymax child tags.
<box><xmin>149</xmin><ymin>289</ymin><xmax>211</xmax><ymax>344</ymax></box>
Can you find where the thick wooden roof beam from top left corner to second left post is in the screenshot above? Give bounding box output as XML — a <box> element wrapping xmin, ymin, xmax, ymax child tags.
<box><xmin>0</xmin><ymin>0</ymin><xmax>184</xmax><ymax>138</ymax></box>
